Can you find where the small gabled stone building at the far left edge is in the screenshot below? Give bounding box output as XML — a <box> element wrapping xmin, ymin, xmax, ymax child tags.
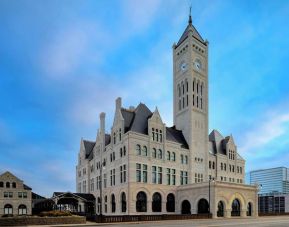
<box><xmin>0</xmin><ymin>172</ymin><xmax>32</xmax><ymax>217</ymax></box>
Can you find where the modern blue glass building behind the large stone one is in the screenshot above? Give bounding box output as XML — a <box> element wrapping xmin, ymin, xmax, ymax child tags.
<box><xmin>248</xmin><ymin>167</ymin><xmax>289</xmax><ymax>194</ymax></box>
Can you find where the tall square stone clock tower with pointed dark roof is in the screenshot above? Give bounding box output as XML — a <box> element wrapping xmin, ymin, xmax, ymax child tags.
<box><xmin>173</xmin><ymin>15</ymin><xmax>208</xmax><ymax>183</ymax></box>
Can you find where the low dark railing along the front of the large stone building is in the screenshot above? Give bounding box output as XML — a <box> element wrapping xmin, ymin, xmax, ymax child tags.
<box><xmin>94</xmin><ymin>214</ymin><xmax>212</xmax><ymax>223</ymax></box>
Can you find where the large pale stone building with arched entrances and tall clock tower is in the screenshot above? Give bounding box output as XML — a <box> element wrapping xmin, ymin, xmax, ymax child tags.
<box><xmin>76</xmin><ymin>12</ymin><xmax>258</xmax><ymax>217</ymax></box>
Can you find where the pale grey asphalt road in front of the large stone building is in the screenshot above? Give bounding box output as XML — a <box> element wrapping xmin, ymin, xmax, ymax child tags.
<box><xmin>51</xmin><ymin>216</ymin><xmax>289</xmax><ymax>227</ymax></box>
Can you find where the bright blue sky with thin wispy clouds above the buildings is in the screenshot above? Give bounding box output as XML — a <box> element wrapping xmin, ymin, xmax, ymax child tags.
<box><xmin>0</xmin><ymin>0</ymin><xmax>289</xmax><ymax>196</ymax></box>
